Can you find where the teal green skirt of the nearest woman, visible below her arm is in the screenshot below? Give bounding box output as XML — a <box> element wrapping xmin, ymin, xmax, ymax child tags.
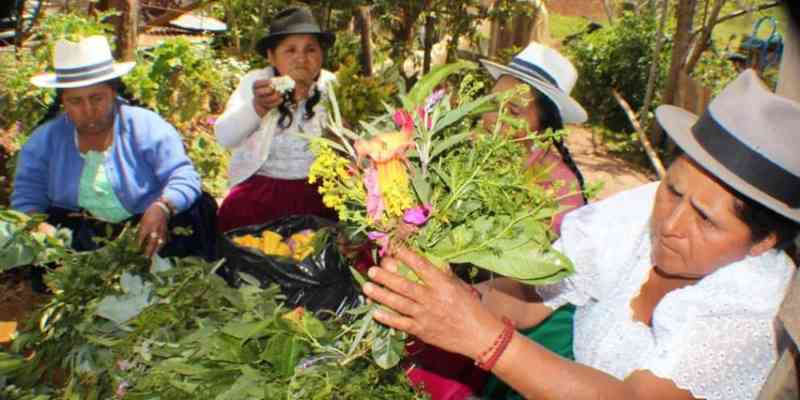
<box><xmin>483</xmin><ymin>304</ymin><xmax>575</xmax><ymax>400</ymax></box>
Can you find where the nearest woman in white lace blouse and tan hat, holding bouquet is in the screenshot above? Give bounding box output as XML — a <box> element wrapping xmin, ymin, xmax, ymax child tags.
<box><xmin>364</xmin><ymin>70</ymin><xmax>800</xmax><ymax>400</ymax></box>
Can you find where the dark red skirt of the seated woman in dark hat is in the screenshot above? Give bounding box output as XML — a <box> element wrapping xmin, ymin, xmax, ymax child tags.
<box><xmin>217</xmin><ymin>175</ymin><xmax>336</xmax><ymax>232</ymax></box>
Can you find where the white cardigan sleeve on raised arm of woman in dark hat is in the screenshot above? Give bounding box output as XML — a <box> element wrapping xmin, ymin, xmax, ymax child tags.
<box><xmin>214</xmin><ymin>68</ymin><xmax>272</xmax><ymax>148</ymax></box>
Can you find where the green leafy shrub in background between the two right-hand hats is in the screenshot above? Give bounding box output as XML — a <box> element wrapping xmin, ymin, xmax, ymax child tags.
<box><xmin>567</xmin><ymin>13</ymin><xmax>670</xmax><ymax>132</ymax></box>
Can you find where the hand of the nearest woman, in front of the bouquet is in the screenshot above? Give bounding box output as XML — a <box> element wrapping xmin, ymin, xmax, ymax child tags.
<box><xmin>364</xmin><ymin>248</ymin><xmax>503</xmax><ymax>359</ymax></box>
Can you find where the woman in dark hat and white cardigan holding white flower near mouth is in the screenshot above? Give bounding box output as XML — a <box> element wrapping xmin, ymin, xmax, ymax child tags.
<box><xmin>214</xmin><ymin>7</ymin><xmax>335</xmax><ymax>232</ymax></box>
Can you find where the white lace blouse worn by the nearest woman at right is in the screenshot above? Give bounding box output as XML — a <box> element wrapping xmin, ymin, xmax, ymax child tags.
<box><xmin>537</xmin><ymin>183</ymin><xmax>794</xmax><ymax>400</ymax></box>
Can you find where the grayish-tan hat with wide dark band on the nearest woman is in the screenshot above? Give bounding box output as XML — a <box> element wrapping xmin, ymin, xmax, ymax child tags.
<box><xmin>656</xmin><ymin>69</ymin><xmax>800</xmax><ymax>222</ymax></box>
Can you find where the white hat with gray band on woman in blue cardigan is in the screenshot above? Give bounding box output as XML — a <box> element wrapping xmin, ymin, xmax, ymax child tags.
<box><xmin>31</xmin><ymin>36</ymin><xmax>136</xmax><ymax>89</ymax></box>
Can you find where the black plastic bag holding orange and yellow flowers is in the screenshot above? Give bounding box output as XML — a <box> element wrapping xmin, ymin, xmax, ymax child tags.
<box><xmin>218</xmin><ymin>215</ymin><xmax>362</xmax><ymax>317</ymax></box>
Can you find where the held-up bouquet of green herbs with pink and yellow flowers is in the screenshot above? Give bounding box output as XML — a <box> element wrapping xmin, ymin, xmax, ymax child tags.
<box><xmin>309</xmin><ymin>62</ymin><xmax>572</xmax><ymax>368</ymax></box>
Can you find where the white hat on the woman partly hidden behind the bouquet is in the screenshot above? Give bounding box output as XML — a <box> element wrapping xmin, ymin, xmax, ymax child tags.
<box><xmin>481</xmin><ymin>42</ymin><xmax>589</xmax><ymax>124</ymax></box>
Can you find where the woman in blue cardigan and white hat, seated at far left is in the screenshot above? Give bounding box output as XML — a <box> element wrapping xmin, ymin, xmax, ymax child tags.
<box><xmin>11</xmin><ymin>36</ymin><xmax>215</xmax><ymax>258</ymax></box>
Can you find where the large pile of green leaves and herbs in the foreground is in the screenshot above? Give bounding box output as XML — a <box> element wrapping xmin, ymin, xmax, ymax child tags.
<box><xmin>0</xmin><ymin>219</ymin><xmax>424</xmax><ymax>400</ymax></box>
